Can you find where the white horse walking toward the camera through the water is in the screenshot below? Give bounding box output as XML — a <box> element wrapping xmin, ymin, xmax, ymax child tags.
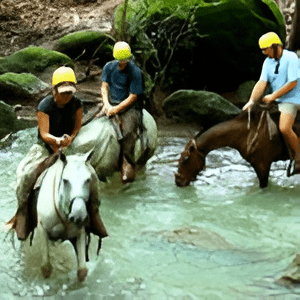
<box><xmin>37</xmin><ymin>153</ymin><xmax>103</xmax><ymax>281</ymax></box>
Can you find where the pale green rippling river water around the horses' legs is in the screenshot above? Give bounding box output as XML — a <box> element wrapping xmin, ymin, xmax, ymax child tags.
<box><xmin>0</xmin><ymin>129</ymin><xmax>300</xmax><ymax>300</ymax></box>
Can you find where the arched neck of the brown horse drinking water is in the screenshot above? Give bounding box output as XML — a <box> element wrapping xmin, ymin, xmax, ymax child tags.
<box><xmin>196</xmin><ymin>119</ymin><xmax>247</xmax><ymax>156</ymax></box>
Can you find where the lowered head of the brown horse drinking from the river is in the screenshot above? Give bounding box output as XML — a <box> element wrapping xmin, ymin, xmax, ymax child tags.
<box><xmin>175</xmin><ymin>139</ymin><xmax>205</xmax><ymax>187</ymax></box>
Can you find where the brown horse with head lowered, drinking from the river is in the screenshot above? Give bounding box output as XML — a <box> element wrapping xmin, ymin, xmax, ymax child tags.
<box><xmin>175</xmin><ymin>104</ymin><xmax>300</xmax><ymax>188</ymax></box>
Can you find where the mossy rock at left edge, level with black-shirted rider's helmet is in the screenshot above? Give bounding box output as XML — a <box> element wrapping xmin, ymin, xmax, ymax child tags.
<box><xmin>0</xmin><ymin>73</ymin><xmax>51</xmax><ymax>103</ymax></box>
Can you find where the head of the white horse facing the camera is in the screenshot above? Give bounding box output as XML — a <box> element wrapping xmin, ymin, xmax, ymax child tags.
<box><xmin>58</xmin><ymin>152</ymin><xmax>93</xmax><ymax>227</ymax></box>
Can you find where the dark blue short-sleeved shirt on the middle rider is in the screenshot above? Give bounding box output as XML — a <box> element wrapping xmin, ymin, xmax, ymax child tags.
<box><xmin>102</xmin><ymin>60</ymin><xmax>144</xmax><ymax>104</ymax></box>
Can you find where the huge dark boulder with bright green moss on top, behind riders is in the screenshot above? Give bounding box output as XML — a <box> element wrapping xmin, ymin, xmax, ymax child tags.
<box><xmin>115</xmin><ymin>0</ymin><xmax>285</xmax><ymax>93</ymax></box>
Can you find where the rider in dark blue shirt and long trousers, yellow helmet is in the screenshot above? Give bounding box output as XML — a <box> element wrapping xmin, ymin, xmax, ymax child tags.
<box><xmin>98</xmin><ymin>41</ymin><xmax>144</xmax><ymax>183</ymax></box>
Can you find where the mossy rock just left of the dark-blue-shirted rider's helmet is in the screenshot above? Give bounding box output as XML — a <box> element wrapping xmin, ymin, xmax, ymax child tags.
<box><xmin>54</xmin><ymin>31</ymin><xmax>114</xmax><ymax>64</ymax></box>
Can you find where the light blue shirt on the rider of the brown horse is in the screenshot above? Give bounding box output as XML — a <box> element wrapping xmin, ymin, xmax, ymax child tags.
<box><xmin>259</xmin><ymin>50</ymin><xmax>300</xmax><ymax>104</ymax></box>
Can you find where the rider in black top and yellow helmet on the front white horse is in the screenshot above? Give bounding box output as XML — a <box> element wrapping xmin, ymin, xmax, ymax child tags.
<box><xmin>8</xmin><ymin>66</ymin><xmax>108</xmax><ymax>240</ymax></box>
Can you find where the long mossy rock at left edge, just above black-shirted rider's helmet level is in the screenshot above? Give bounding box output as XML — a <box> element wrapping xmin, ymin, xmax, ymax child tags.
<box><xmin>0</xmin><ymin>46</ymin><xmax>74</xmax><ymax>75</ymax></box>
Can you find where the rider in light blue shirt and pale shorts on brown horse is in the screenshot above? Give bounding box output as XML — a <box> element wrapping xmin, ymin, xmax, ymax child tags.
<box><xmin>243</xmin><ymin>32</ymin><xmax>300</xmax><ymax>174</ymax></box>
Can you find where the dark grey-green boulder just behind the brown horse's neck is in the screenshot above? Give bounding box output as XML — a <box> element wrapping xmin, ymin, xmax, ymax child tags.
<box><xmin>163</xmin><ymin>90</ymin><xmax>241</xmax><ymax>128</ymax></box>
